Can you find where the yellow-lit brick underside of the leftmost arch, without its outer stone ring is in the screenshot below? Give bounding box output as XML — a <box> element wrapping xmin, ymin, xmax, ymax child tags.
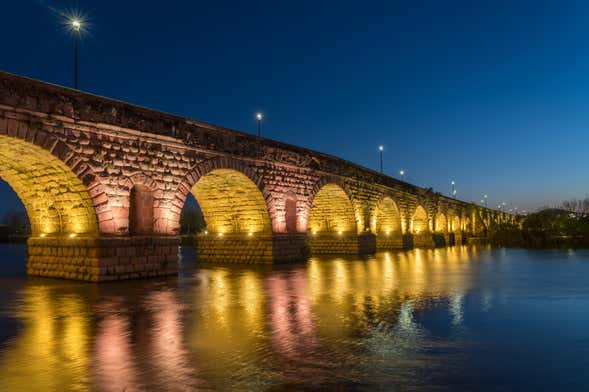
<box><xmin>0</xmin><ymin>135</ymin><xmax>98</xmax><ymax>236</ymax></box>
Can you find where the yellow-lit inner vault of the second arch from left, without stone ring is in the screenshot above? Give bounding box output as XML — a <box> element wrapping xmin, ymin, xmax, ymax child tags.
<box><xmin>192</xmin><ymin>169</ymin><xmax>272</xmax><ymax>236</ymax></box>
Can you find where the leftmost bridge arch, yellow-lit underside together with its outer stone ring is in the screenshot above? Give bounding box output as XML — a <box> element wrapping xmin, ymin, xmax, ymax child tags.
<box><xmin>0</xmin><ymin>130</ymin><xmax>109</xmax><ymax>236</ymax></box>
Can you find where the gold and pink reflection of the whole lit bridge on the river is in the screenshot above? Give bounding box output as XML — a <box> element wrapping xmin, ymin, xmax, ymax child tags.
<box><xmin>0</xmin><ymin>247</ymin><xmax>544</xmax><ymax>391</ymax></box>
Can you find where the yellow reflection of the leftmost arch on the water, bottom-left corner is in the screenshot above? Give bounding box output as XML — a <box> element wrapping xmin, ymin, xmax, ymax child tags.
<box><xmin>0</xmin><ymin>283</ymin><xmax>92</xmax><ymax>390</ymax></box>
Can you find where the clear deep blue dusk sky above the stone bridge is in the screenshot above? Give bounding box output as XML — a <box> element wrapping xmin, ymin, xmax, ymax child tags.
<box><xmin>0</xmin><ymin>0</ymin><xmax>589</xmax><ymax>217</ymax></box>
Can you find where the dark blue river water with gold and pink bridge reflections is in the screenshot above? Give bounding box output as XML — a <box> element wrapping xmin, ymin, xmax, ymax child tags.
<box><xmin>0</xmin><ymin>245</ymin><xmax>589</xmax><ymax>391</ymax></box>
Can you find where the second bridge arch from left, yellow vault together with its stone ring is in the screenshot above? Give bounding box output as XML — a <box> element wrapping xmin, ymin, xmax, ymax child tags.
<box><xmin>173</xmin><ymin>157</ymin><xmax>279</xmax><ymax>233</ymax></box>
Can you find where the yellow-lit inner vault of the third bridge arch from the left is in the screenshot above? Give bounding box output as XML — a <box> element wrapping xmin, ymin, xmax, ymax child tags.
<box><xmin>308</xmin><ymin>183</ymin><xmax>357</xmax><ymax>235</ymax></box>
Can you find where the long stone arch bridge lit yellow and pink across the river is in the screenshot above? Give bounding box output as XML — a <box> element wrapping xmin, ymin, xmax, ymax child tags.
<box><xmin>0</xmin><ymin>72</ymin><xmax>515</xmax><ymax>281</ymax></box>
